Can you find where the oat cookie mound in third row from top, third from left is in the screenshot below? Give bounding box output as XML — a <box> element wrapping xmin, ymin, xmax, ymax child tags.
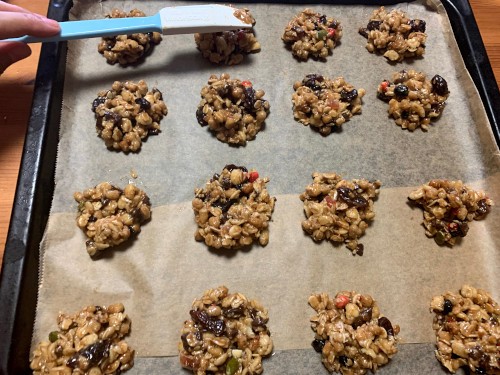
<box><xmin>300</xmin><ymin>172</ymin><xmax>381</xmax><ymax>255</ymax></box>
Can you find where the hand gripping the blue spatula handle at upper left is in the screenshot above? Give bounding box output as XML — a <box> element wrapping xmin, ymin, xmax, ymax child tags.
<box><xmin>0</xmin><ymin>1</ymin><xmax>60</xmax><ymax>74</ymax></box>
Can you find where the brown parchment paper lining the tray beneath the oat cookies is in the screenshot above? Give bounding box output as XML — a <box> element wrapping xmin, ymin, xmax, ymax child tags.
<box><xmin>33</xmin><ymin>0</ymin><xmax>500</xmax><ymax>373</ymax></box>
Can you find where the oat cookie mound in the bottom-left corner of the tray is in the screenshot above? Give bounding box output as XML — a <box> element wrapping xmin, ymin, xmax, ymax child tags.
<box><xmin>30</xmin><ymin>303</ymin><xmax>135</xmax><ymax>375</ymax></box>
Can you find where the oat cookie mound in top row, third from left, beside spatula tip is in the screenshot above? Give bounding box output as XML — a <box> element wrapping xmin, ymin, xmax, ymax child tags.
<box><xmin>281</xmin><ymin>8</ymin><xmax>342</xmax><ymax>61</ymax></box>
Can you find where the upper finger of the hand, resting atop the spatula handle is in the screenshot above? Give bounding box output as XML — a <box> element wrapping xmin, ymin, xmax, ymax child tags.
<box><xmin>0</xmin><ymin>10</ymin><xmax>60</xmax><ymax>39</ymax></box>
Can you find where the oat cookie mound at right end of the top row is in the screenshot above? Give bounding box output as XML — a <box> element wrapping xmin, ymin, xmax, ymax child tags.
<box><xmin>359</xmin><ymin>7</ymin><xmax>427</xmax><ymax>62</ymax></box>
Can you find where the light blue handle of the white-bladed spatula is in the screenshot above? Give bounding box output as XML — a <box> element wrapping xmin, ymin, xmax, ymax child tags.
<box><xmin>5</xmin><ymin>14</ymin><xmax>162</xmax><ymax>43</ymax></box>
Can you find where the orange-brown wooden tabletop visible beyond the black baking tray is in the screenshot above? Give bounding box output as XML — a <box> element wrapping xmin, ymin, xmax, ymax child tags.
<box><xmin>0</xmin><ymin>0</ymin><xmax>500</xmax><ymax>272</ymax></box>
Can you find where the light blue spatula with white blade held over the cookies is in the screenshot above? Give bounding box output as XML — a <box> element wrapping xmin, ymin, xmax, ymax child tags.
<box><xmin>6</xmin><ymin>4</ymin><xmax>252</xmax><ymax>43</ymax></box>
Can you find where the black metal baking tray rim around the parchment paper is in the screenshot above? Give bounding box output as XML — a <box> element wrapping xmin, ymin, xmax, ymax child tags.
<box><xmin>0</xmin><ymin>0</ymin><xmax>500</xmax><ymax>374</ymax></box>
